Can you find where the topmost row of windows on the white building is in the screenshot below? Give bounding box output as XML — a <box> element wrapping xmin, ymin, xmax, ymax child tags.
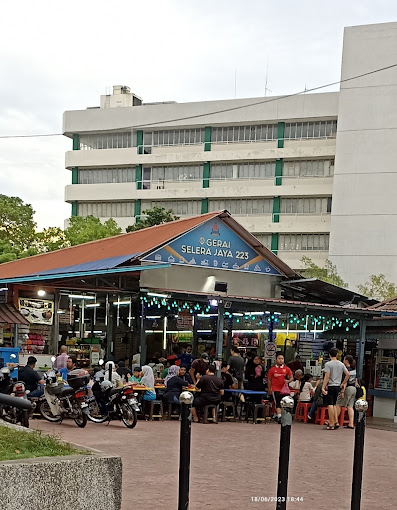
<box><xmin>79</xmin><ymin>120</ymin><xmax>337</xmax><ymax>152</ymax></box>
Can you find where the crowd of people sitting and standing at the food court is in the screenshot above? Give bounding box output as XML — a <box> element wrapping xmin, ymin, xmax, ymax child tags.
<box><xmin>19</xmin><ymin>345</ymin><xmax>365</xmax><ymax>430</ymax></box>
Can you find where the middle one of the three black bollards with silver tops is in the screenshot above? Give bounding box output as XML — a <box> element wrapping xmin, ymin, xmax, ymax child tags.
<box><xmin>276</xmin><ymin>396</ymin><xmax>294</xmax><ymax>510</ymax></box>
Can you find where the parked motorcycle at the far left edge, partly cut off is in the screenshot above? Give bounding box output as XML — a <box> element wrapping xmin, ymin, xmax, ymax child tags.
<box><xmin>0</xmin><ymin>367</ymin><xmax>32</xmax><ymax>428</ymax></box>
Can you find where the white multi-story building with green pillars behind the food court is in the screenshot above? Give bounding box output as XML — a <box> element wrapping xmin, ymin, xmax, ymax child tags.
<box><xmin>63</xmin><ymin>23</ymin><xmax>397</xmax><ymax>286</ymax></box>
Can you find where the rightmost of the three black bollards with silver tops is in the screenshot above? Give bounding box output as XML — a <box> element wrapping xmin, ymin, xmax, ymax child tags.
<box><xmin>350</xmin><ymin>400</ymin><xmax>368</xmax><ymax>510</ymax></box>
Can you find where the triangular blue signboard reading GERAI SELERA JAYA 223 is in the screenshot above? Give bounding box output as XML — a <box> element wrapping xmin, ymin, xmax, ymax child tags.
<box><xmin>144</xmin><ymin>218</ymin><xmax>280</xmax><ymax>275</ymax></box>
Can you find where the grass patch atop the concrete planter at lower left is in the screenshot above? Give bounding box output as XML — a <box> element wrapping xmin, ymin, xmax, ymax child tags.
<box><xmin>0</xmin><ymin>425</ymin><xmax>88</xmax><ymax>461</ymax></box>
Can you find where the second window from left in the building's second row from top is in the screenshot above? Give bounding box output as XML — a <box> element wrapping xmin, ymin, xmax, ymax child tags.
<box><xmin>143</xmin><ymin>165</ymin><xmax>203</xmax><ymax>189</ymax></box>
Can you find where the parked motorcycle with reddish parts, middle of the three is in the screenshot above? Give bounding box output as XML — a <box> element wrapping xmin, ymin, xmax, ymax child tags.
<box><xmin>40</xmin><ymin>369</ymin><xmax>90</xmax><ymax>428</ymax></box>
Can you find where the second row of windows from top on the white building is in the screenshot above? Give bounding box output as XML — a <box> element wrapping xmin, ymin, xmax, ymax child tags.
<box><xmin>79</xmin><ymin>159</ymin><xmax>334</xmax><ymax>189</ymax></box>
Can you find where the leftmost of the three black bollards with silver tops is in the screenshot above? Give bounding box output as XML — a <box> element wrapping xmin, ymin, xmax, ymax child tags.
<box><xmin>178</xmin><ymin>391</ymin><xmax>193</xmax><ymax>510</ymax></box>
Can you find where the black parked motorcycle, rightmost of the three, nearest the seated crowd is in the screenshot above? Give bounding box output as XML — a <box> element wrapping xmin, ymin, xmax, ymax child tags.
<box><xmin>82</xmin><ymin>380</ymin><xmax>139</xmax><ymax>429</ymax></box>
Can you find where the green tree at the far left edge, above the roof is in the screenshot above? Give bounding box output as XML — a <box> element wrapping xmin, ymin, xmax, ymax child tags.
<box><xmin>0</xmin><ymin>194</ymin><xmax>36</xmax><ymax>252</ymax></box>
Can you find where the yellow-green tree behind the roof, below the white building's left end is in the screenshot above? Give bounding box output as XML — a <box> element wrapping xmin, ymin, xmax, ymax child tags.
<box><xmin>65</xmin><ymin>216</ymin><xmax>121</xmax><ymax>246</ymax></box>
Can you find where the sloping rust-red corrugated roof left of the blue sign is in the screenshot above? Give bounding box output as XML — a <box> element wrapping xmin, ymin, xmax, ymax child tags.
<box><xmin>0</xmin><ymin>211</ymin><xmax>220</xmax><ymax>278</ymax></box>
